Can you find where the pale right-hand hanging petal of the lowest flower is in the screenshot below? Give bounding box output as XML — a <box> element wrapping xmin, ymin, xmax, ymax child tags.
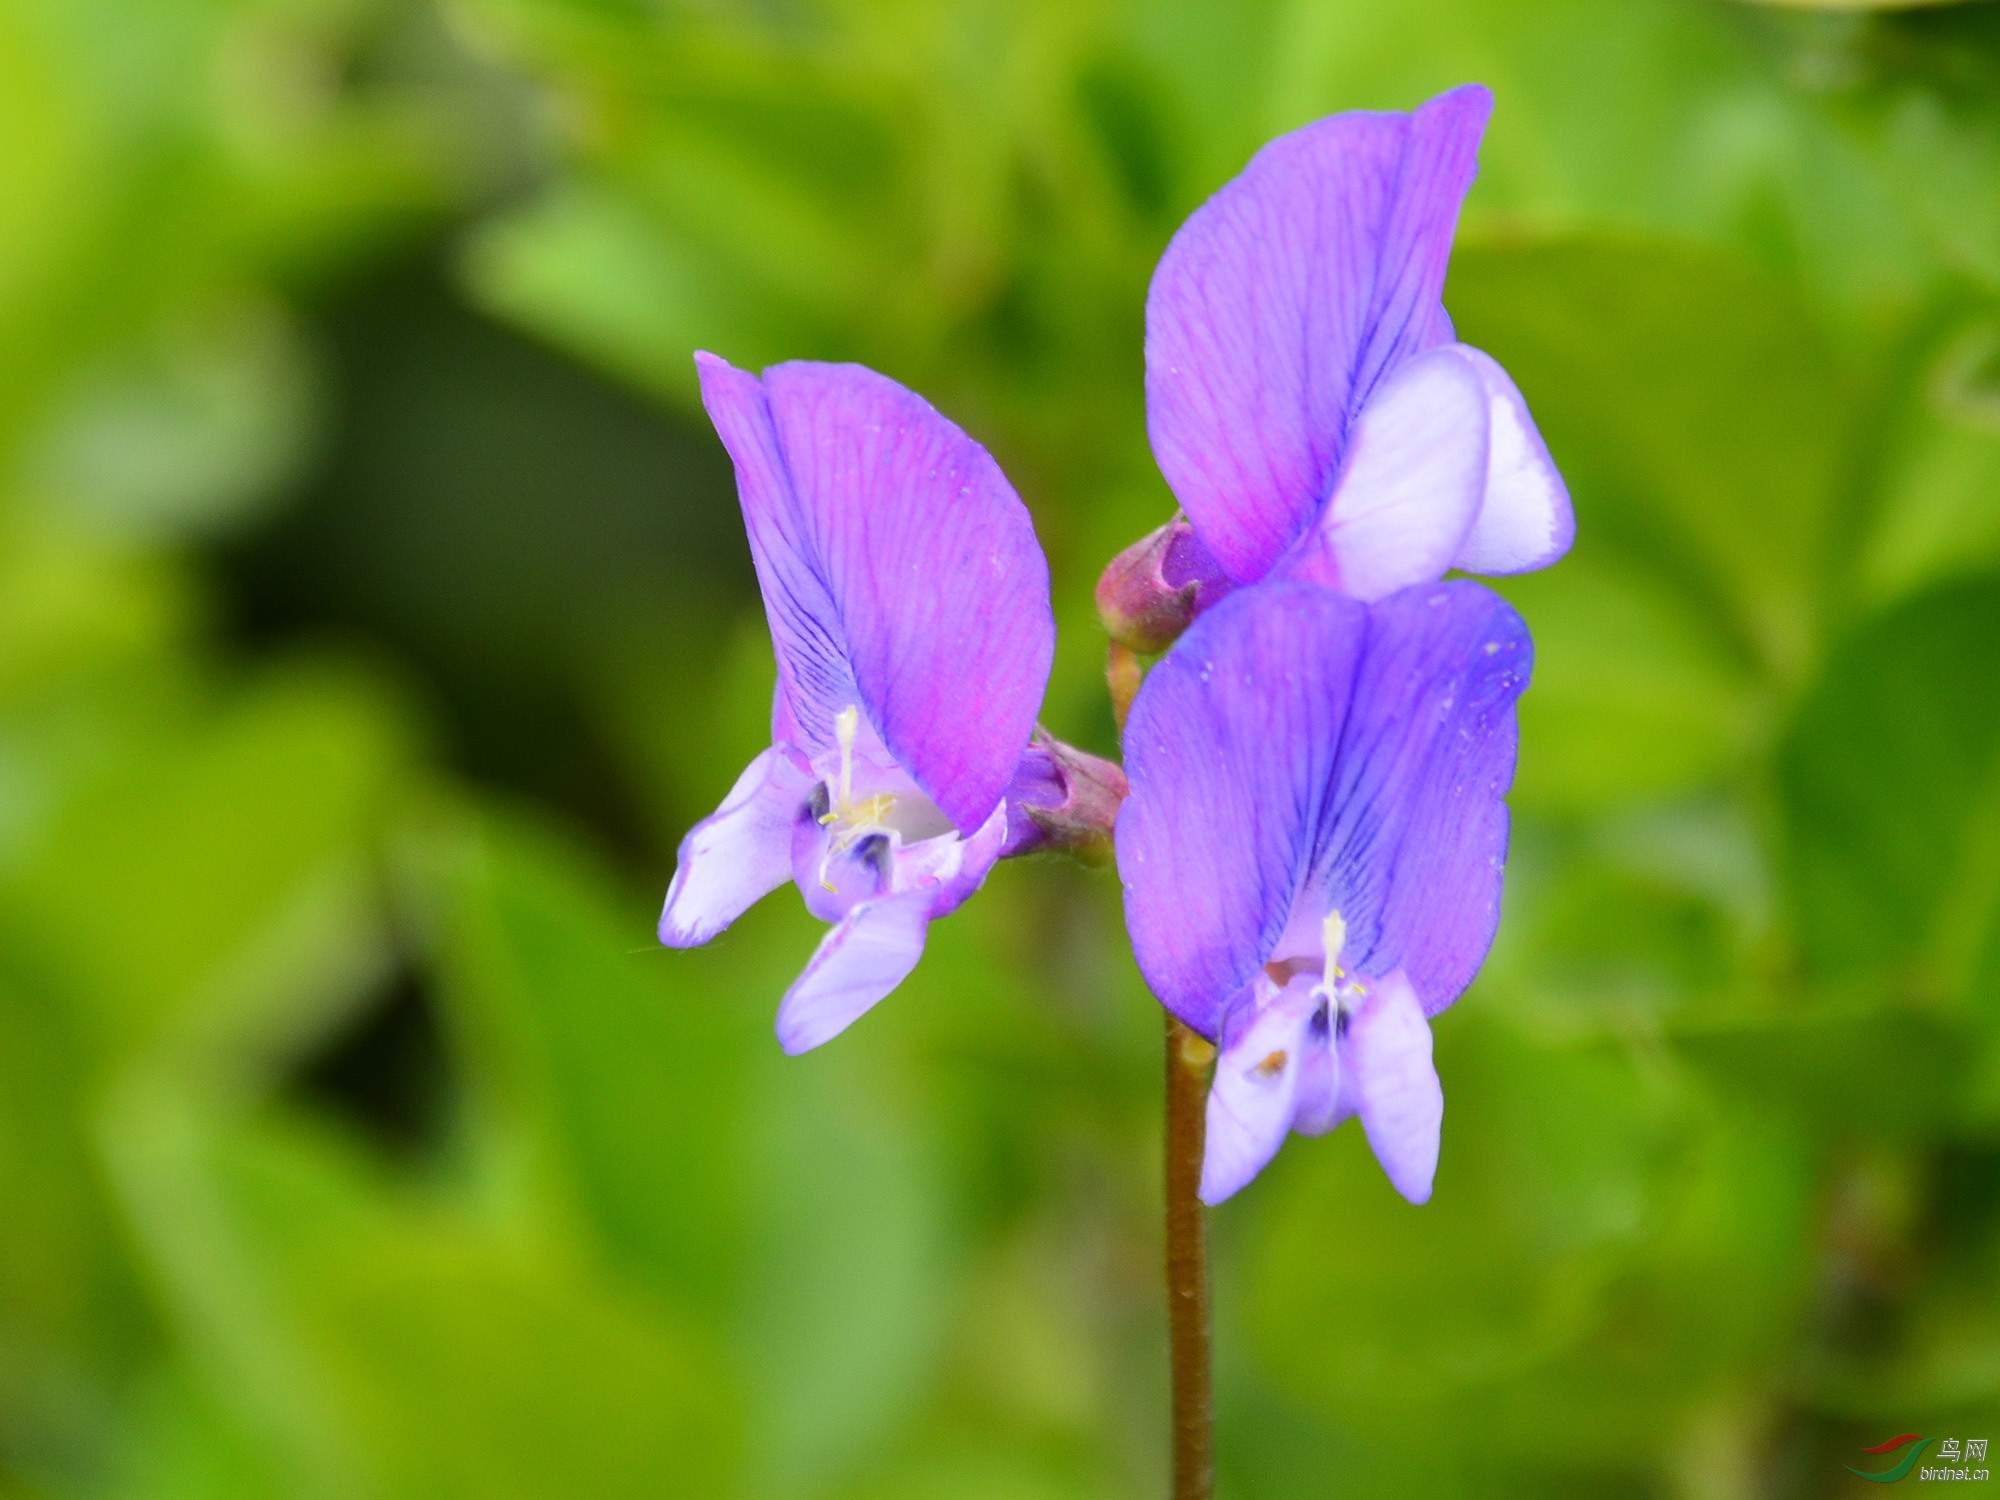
<box><xmin>1338</xmin><ymin>972</ymin><xmax>1444</xmax><ymax>1204</ymax></box>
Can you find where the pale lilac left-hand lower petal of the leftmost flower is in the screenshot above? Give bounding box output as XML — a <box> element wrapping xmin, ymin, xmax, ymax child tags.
<box><xmin>660</xmin><ymin>744</ymin><xmax>812</xmax><ymax>948</ymax></box>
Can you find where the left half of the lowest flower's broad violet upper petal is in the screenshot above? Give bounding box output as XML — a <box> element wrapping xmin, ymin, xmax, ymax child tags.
<box><xmin>1116</xmin><ymin>584</ymin><xmax>1368</xmax><ymax>1038</ymax></box>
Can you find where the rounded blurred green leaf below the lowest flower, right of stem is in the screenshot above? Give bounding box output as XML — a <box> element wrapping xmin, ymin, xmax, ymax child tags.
<box><xmin>1248</xmin><ymin>1014</ymin><xmax>1812</xmax><ymax>1464</ymax></box>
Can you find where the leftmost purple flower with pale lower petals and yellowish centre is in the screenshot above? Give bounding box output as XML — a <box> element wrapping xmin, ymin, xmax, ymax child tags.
<box><xmin>660</xmin><ymin>354</ymin><xmax>1066</xmax><ymax>1052</ymax></box>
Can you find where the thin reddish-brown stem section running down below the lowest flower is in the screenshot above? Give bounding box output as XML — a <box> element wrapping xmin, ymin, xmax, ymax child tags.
<box><xmin>1166</xmin><ymin>1016</ymin><xmax>1216</xmax><ymax>1500</ymax></box>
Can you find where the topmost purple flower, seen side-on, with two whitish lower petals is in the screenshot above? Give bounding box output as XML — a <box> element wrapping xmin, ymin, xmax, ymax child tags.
<box><xmin>1146</xmin><ymin>84</ymin><xmax>1574</xmax><ymax>606</ymax></box>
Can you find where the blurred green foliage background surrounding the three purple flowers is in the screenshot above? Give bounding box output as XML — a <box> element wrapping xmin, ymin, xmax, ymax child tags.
<box><xmin>0</xmin><ymin>0</ymin><xmax>2000</xmax><ymax>1500</ymax></box>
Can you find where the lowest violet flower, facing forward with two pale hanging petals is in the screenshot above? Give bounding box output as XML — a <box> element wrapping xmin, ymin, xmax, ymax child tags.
<box><xmin>1116</xmin><ymin>582</ymin><xmax>1532</xmax><ymax>1204</ymax></box>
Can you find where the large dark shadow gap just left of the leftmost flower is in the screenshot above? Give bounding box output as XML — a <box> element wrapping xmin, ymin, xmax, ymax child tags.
<box><xmin>220</xmin><ymin>258</ymin><xmax>756</xmax><ymax>852</ymax></box>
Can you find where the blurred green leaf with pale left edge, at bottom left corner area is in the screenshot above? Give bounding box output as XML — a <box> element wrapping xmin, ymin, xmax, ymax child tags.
<box><xmin>112</xmin><ymin>1084</ymin><xmax>738</xmax><ymax>1500</ymax></box>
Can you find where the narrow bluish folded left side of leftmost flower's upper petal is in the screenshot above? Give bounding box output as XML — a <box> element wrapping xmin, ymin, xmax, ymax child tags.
<box><xmin>694</xmin><ymin>354</ymin><xmax>860</xmax><ymax>756</ymax></box>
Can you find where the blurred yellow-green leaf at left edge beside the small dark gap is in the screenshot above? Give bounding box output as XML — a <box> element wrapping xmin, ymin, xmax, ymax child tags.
<box><xmin>0</xmin><ymin>656</ymin><xmax>410</xmax><ymax>1066</ymax></box>
